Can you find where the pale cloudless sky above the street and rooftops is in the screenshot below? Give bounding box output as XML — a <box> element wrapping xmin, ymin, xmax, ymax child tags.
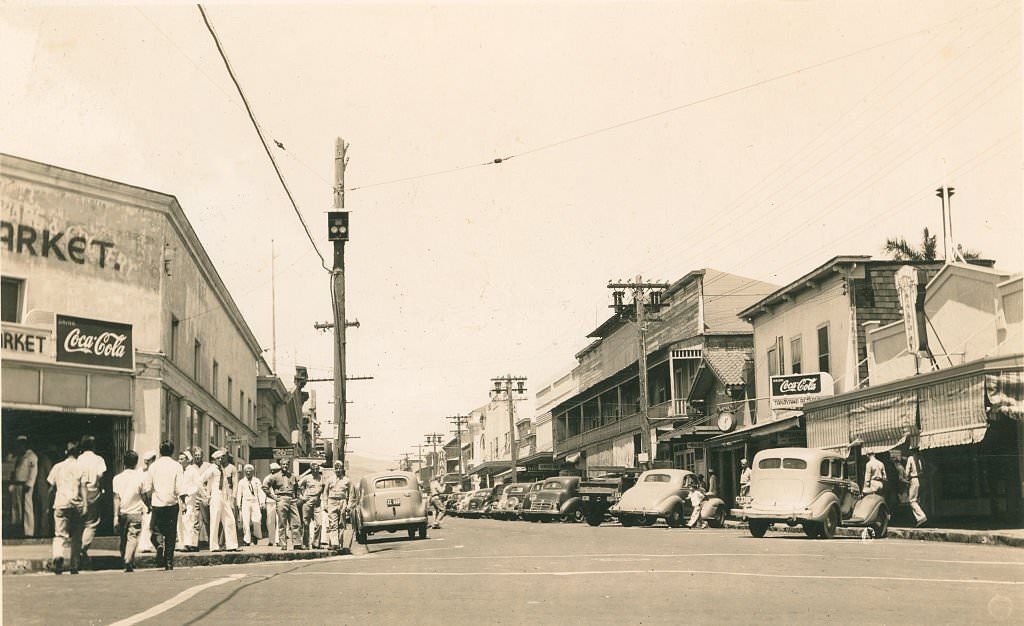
<box><xmin>0</xmin><ymin>0</ymin><xmax>1024</xmax><ymax>459</ymax></box>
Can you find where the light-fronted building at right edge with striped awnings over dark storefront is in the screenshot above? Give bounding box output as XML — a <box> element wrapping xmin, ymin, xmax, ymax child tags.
<box><xmin>804</xmin><ymin>263</ymin><xmax>1024</xmax><ymax>528</ymax></box>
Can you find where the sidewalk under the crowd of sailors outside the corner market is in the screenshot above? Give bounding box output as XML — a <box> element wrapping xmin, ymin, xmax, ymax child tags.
<box><xmin>3</xmin><ymin>537</ymin><xmax>338</xmax><ymax>576</ymax></box>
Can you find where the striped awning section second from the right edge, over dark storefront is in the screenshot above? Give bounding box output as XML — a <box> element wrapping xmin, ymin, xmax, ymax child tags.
<box><xmin>919</xmin><ymin>374</ymin><xmax>988</xmax><ymax>450</ymax></box>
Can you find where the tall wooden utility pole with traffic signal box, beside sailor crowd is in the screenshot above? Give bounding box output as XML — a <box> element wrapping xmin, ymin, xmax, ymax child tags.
<box><xmin>328</xmin><ymin>137</ymin><xmax>348</xmax><ymax>467</ymax></box>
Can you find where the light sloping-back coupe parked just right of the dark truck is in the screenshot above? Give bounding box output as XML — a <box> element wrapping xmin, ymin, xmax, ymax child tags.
<box><xmin>608</xmin><ymin>469</ymin><xmax>712</xmax><ymax>528</ymax></box>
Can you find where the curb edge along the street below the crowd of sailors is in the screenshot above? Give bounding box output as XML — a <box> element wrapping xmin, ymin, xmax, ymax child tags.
<box><xmin>3</xmin><ymin>550</ymin><xmax>342</xmax><ymax>576</ymax></box>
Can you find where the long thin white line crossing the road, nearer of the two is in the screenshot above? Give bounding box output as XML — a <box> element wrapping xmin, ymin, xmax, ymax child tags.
<box><xmin>285</xmin><ymin>570</ymin><xmax>1024</xmax><ymax>586</ymax></box>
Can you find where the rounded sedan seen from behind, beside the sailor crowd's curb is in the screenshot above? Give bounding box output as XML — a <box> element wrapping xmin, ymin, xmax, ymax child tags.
<box><xmin>352</xmin><ymin>471</ymin><xmax>427</xmax><ymax>543</ymax></box>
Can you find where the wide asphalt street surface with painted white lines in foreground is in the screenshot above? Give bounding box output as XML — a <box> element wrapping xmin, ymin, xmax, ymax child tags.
<box><xmin>3</xmin><ymin>518</ymin><xmax>1024</xmax><ymax>626</ymax></box>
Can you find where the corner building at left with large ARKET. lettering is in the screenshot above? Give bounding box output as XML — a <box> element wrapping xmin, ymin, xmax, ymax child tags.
<box><xmin>0</xmin><ymin>155</ymin><xmax>261</xmax><ymax>535</ymax></box>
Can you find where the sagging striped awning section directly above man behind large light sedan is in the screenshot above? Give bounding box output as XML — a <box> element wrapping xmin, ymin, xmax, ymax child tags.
<box><xmin>849</xmin><ymin>390</ymin><xmax>918</xmax><ymax>454</ymax></box>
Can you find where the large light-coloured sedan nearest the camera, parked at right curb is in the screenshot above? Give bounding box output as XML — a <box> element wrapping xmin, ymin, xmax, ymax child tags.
<box><xmin>734</xmin><ymin>448</ymin><xmax>889</xmax><ymax>539</ymax></box>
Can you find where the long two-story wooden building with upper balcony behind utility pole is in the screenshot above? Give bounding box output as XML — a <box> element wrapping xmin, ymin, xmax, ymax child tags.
<box><xmin>551</xmin><ymin>268</ymin><xmax>775</xmax><ymax>471</ymax></box>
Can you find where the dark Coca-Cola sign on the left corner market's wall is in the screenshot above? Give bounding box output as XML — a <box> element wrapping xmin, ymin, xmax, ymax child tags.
<box><xmin>56</xmin><ymin>315</ymin><xmax>134</xmax><ymax>370</ymax></box>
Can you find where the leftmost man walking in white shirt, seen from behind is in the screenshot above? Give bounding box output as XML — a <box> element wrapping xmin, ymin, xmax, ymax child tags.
<box><xmin>46</xmin><ymin>443</ymin><xmax>87</xmax><ymax>574</ymax></box>
